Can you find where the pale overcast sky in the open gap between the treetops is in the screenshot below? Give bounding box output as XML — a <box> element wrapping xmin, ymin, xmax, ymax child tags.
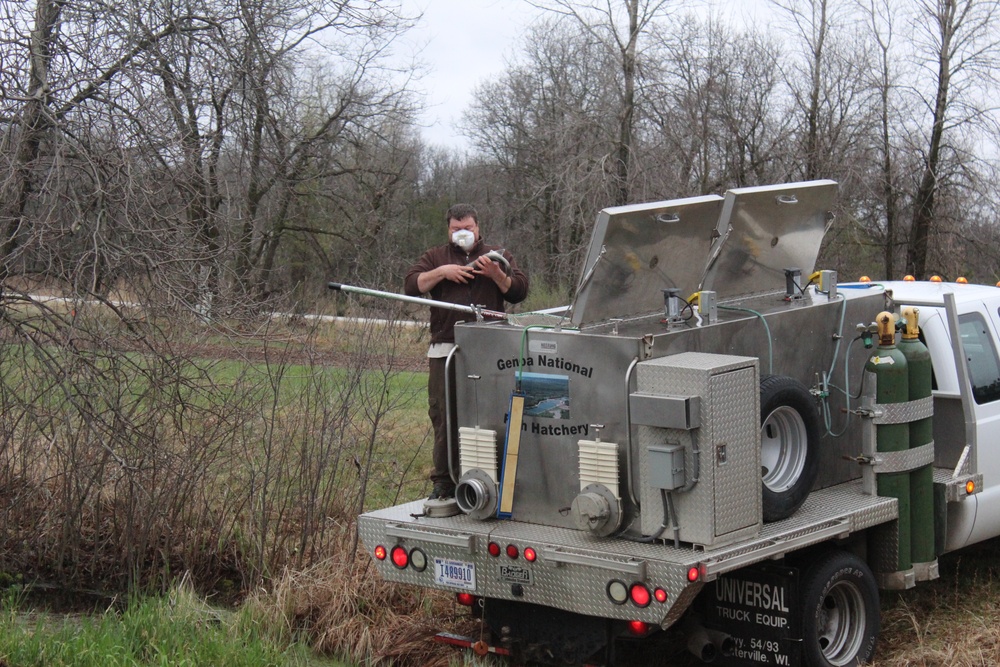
<box><xmin>403</xmin><ymin>0</ymin><xmax>766</xmax><ymax>150</ymax></box>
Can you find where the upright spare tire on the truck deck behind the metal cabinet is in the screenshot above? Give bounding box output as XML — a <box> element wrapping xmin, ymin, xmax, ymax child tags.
<box><xmin>760</xmin><ymin>375</ymin><xmax>820</xmax><ymax>521</ymax></box>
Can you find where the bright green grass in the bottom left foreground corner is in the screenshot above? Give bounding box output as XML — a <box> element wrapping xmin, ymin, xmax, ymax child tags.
<box><xmin>0</xmin><ymin>591</ymin><xmax>349</xmax><ymax>667</ymax></box>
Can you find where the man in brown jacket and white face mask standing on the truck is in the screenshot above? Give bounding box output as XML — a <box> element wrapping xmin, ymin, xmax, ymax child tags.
<box><xmin>404</xmin><ymin>204</ymin><xmax>528</xmax><ymax>499</ymax></box>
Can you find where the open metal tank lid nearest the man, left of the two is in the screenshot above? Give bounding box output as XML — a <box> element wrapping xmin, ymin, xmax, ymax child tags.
<box><xmin>572</xmin><ymin>195</ymin><xmax>724</xmax><ymax>325</ymax></box>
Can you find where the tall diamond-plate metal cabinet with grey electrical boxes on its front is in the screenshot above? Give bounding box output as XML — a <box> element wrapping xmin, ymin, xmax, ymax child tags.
<box><xmin>629</xmin><ymin>352</ymin><xmax>762</xmax><ymax>547</ymax></box>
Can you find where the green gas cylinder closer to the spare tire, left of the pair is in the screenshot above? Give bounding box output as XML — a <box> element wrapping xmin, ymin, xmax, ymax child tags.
<box><xmin>865</xmin><ymin>312</ymin><xmax>913</xmax><ymax>571</ymax></box>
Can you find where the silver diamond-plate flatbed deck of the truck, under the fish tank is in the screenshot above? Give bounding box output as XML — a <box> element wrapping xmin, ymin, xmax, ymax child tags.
<box><xmin>359</xmin><ymin>482</ymin><xmax>897</xmax><ymax>627</ymax></box>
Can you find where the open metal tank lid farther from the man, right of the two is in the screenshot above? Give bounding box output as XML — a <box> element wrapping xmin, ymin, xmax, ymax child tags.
<box><xmin>700</xmin><ymin>180</ymin><xmax>837</xmax><ymax>299</ymax></box>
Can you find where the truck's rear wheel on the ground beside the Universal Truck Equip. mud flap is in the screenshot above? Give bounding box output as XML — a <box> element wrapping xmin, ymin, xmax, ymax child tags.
<box><xmin>800</xmin><ymin>551</ymin><xmax>880</xmax><ymax>667</ymax></box>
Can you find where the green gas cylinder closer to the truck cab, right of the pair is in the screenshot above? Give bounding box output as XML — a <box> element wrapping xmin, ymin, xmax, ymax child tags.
<box><xmin>899</xmin><ymin>307</ymin><xmax>936</xmax><ymax>566</ymax></box>
